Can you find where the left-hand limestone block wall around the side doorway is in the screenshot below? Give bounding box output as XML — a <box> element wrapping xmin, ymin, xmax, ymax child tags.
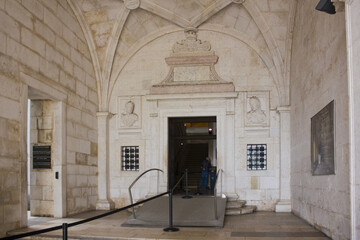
<box><xmin>0</xmin><ymin>0</ymin><xmax>97</xmax><ymax>236</ymax></box>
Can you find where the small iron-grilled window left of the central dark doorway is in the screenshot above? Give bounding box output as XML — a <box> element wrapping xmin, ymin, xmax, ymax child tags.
<box><xmin>121</xmin><ymin>146</ymin><xmax>139</xmax><ymax>171</ymax></box>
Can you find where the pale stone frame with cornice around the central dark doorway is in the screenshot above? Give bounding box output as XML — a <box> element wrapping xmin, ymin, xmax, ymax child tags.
<box><xmin>147</xmin><ymin>92</ymin><xmax>238</xmax><ymax>198</ymax></box>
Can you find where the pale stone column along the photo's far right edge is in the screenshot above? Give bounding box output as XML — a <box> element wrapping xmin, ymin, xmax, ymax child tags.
<box><xmin>342</xmin><ymin>0</ymin><xmax>360</xmax><ymax>239</ymax></box>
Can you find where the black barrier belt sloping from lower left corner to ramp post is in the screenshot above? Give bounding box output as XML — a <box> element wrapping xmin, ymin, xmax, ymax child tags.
<box><xmin>0</xmin><ymin>191</ymin><xmax>170</xmax><ymax>240</ymax></box>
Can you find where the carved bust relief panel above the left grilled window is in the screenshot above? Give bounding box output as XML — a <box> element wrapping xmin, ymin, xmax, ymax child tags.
<box><xmin>117</xmin><ymin>97</ymin><xmax>141</xmax><ymax>128</ymax></box>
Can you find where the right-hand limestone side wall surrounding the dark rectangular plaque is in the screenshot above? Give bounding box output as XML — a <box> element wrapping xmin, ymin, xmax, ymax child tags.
<box><xmin>291</xmin><ymin>0</ymin><xmax>350</xmax><ymax>239</ymax></box>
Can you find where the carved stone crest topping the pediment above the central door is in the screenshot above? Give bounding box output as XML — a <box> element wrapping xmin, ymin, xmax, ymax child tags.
<box><xmin>172</xmin><ymin>28</ymin><xmax>211</xmax><ymax>53</ymax></box>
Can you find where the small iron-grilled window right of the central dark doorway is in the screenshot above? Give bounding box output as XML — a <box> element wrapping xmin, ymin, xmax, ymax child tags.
<box><xmin>247</xmin><ymin>144</ymin><xmax>267</xmax><ymax>170</ymax></box>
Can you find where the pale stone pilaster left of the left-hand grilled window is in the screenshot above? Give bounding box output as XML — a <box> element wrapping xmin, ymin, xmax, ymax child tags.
<box><xmin>96</xmin><ymin>112</ymin><xmax>114</xmax><ymax>210</ymax></box>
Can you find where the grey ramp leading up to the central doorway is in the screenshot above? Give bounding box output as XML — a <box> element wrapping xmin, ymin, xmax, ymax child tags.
<box><xmin>122</xmin><ymin>196</ymin><xmax>226</xmax><ymax>227</ymax></box>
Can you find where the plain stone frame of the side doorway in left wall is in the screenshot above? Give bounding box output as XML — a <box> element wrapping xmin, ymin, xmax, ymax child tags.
<box><xmin>20</xmin><ymin>72</ymin><xmax>67</xmax><ymax>226</ymax></box>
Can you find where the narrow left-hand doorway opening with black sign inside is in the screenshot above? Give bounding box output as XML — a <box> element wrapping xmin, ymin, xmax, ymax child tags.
<box><xmin>27</xmin><ymin>96</ymin><xmax>54</xmax><ymax>217</ymax></box>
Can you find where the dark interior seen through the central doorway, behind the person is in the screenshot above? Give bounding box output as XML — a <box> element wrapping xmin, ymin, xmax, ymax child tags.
<box><xmin>168</xmin><ymin>117</ymin><xmax>217</xmax><ymax>195</ymax></box>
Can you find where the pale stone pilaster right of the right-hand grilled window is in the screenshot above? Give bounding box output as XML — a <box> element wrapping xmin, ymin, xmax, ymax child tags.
<box><xmin>275</xmin><ymin>106</ymin><xmax>291</xmax><ymax>212</ymax></box>
